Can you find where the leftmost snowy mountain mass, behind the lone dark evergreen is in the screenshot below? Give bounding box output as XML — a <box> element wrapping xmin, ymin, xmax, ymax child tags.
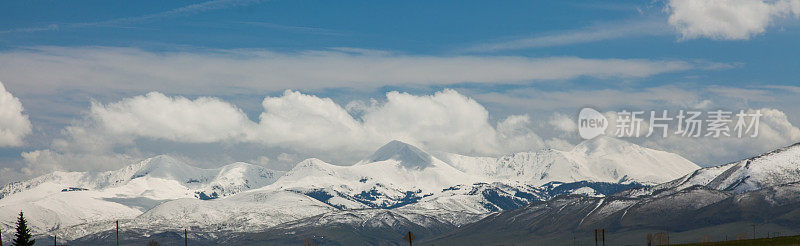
<box><xmin>0</xmin><ymin>156</ymin><xmax>282</xmax><ymax>240</ymax></box>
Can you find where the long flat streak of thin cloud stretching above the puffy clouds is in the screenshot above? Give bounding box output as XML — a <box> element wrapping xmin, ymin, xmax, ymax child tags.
<box><xmin>0</xmin><ymin>47</ymin><xmax>709</xmax><ymax>95</ymax></box>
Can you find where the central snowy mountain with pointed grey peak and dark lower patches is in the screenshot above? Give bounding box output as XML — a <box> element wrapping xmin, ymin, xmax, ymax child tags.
<box><xmin>265</xmin><ymin>141</ymin><xmax>479</xmax><ymax>209</ymax></box>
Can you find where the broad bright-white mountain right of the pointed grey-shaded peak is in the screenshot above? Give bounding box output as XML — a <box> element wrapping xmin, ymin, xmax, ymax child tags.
<box><xmin>443</xmin><ymin>136</ymin><xmax>700</xmax><ymax>186</ymax></box>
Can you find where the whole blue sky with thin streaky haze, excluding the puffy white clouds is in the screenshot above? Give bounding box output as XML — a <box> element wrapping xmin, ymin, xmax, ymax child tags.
<box><xmin>0</xmin><ymin>0</ymin><xmax>800</xmax><ymax>184</ymax></box>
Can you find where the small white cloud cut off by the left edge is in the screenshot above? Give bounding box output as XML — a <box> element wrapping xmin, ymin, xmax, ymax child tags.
<box><xmin>0</xmin><ymin>82</ymin><xmax>31</xmax><ymax>147</ymax></box>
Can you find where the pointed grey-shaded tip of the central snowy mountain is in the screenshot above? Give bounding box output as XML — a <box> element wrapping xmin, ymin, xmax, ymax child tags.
<box><xmin>363</xmin><ymin>140</ymin><xmax>433</xmax><ymax>168</ymax></box>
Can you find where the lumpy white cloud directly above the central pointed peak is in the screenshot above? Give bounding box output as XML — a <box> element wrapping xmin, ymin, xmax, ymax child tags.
<box><xmin>245</xmin><ymin>90</ymin><xmax>542</xmax><ymax>156</ymax></box>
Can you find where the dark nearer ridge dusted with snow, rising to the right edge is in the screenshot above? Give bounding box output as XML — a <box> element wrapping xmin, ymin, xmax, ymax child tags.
<box><xmin>432</xmin><ymin>141</ymin><xmax>800</xmax><ymax>245</ymax></box>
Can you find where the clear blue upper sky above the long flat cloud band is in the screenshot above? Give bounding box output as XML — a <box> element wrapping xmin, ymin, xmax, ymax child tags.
<box><xmin>0</xmin><ymin>1</ymin><xmax>799</xmax><ymax>85</ymax></box>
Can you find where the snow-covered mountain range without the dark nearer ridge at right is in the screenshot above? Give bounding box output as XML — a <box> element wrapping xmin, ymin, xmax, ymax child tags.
<box><xmin>0</xmin><ymin>138</ymin><xmax>708</xmax><ymax>243</ymax></box>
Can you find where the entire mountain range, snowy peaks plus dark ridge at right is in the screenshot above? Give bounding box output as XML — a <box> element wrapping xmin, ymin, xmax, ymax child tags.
<box><xmin>15</xmin><ymin>137</ymin><xmax>800</xmax><ymax>245</ymax></box>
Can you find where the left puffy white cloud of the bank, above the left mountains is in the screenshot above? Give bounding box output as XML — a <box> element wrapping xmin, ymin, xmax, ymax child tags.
<box><xmin>89</xmin><ymin>92</ymin><xmax>252</xmax><ymax>143</ymax></box>
